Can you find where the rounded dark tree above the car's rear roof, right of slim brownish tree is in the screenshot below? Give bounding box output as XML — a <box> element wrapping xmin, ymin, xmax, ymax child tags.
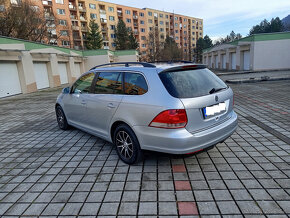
<box><xmin>160</xmin><ymin>37</ymin><xmax>182</xmax><ymax>61</ymax></box>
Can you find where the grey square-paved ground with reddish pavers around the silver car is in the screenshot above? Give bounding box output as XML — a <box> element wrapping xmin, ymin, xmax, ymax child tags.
<box><xmin>0</xmin><ymin>81</ymin><xmax>290</xmax><ymax>218</ymax></box>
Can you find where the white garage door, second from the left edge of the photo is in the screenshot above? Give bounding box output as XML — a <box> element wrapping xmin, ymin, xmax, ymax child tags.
<box><xmin>33</xmin><ymin>63</ymin><xmax>49</xmax><ymax>89</ymax></box>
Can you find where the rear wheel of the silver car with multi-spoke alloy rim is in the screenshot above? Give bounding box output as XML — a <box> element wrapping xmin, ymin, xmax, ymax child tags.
<box><xmin>113</xmin><ymin>124</ymin><xmax>143</xmax><ymax>165</ymax></box>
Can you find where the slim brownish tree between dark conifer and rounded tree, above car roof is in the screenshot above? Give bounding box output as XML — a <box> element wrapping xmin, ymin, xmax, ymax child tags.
<box><xmin>146</xmin><ymin>28</ymin><xmax>163</xmax><ymax>62</ymax></box>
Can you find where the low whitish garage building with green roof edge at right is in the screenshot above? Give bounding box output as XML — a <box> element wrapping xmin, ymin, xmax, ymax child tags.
<box><xmin>202</xmin><ymin>32</ymin><xmax>290</xmax><ymax>71</ymax></box>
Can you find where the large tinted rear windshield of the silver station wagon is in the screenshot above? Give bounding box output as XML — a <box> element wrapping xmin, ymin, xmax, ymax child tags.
<box><xmin>159</xmin><ymin>68</ymin><xmax>228</xmax><ymax>98</ymax></box>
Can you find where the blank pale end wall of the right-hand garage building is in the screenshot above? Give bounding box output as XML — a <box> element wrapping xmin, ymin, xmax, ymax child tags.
<box><xmin>253</xmin><ymin>39</ymin><xmax>290</xmax><ymax>70</ymax></box>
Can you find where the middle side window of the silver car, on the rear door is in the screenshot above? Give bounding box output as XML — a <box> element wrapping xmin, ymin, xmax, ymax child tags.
<box><xmin>95</xmin><ymin>72</ymin><xmax>123</xmax><ymax>94</ymax></box>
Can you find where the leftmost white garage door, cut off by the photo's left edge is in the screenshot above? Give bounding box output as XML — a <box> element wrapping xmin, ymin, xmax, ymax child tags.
<box><xmin>0</xmin><ymin>62</ymin><xmax>21</xmax><ymax>98</ymax></box>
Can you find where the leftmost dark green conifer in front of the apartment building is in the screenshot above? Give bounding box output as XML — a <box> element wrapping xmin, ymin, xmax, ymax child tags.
<box><xmin>86</xmin><ymin>19</ymin><xmax>103</xmax><ymax>50</ymax></box>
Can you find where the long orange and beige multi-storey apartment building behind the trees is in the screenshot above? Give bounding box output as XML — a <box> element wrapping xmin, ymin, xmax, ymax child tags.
<box><xmin>0</xmin><ymin>0</ymin><xmax>203</xmax><ymax>54</ymax></box>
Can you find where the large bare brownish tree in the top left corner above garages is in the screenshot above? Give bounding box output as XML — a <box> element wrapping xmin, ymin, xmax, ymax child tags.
<box><xmin>0</xmin><ymin>0</ymin><xmax>69</xmax><ymax>43</ymax></box>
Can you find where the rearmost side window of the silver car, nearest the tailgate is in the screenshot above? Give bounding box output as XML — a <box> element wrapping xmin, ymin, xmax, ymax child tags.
<box><xmin>124</xmin><ymin>72</ymin><xmax>148</xmax><ymax>95</ymax></box>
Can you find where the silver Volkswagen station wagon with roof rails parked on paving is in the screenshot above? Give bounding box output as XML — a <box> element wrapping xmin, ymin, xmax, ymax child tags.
<box><xmin>55</xmin><ymin>62</ymin><xmax>238</xmax><ymax>164</ymax></box>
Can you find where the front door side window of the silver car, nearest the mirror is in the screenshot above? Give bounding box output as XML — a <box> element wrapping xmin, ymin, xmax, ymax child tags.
<box><xmin>72</xmin><ymin>73</ymin><xmax>95</xmax><ymax>94</ymax></box>
